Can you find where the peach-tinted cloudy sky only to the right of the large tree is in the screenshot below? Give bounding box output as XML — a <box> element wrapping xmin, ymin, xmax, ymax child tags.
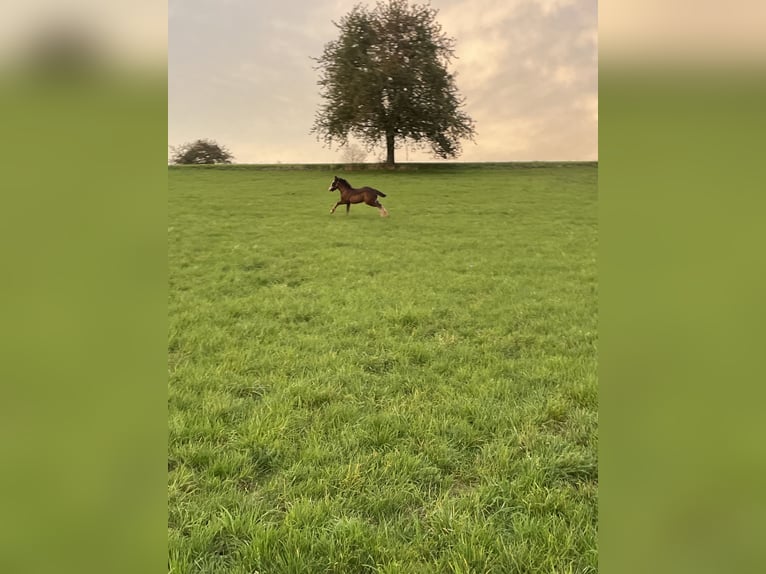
<box><xmin>440</xmin><ymin>0</ymin><xmax>598</xmax><ymax>160</ymax></box>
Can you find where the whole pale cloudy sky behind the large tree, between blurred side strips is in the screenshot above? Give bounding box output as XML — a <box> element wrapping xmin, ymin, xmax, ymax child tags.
<box><xmin>168</xmin><ymin>0</ymin><xmax>598</xmax><ymax>163</ymax></box>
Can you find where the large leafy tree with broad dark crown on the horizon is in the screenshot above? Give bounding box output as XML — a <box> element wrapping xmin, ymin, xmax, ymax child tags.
<box><xmin>312</xmin><ymin>0</ymin><xmax>475</xmax><ymax>166</ymax></box>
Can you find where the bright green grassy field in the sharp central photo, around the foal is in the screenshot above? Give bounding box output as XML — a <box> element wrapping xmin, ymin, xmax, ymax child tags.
<box><xmin>168</xmin><ymin>164</ymin><xmax>598</xmax><ymax>574</ymax></box>
